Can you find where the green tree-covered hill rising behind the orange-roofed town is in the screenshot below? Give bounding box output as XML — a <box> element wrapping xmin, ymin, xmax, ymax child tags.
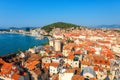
<box><xmin>41</xmin><ymin>22</ymin><xmax>83</xmax><ymax>32</ymax></box>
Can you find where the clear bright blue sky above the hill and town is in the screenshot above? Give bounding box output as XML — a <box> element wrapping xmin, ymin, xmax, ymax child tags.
<box><xmin>0</xmin><ymin>0</ymin><xmax>120</xmax><ymax>28</ymax></box>
